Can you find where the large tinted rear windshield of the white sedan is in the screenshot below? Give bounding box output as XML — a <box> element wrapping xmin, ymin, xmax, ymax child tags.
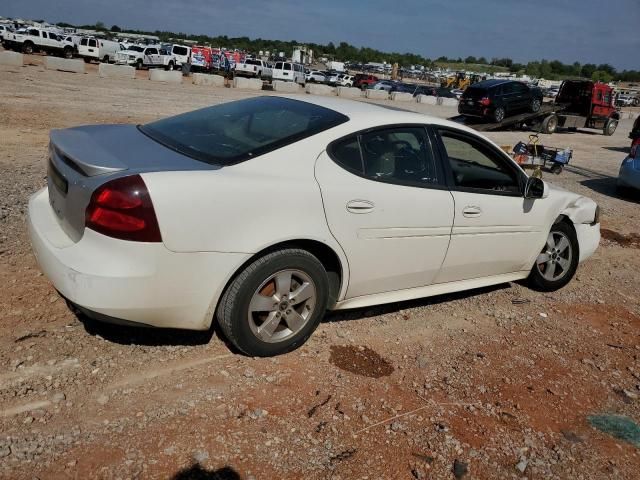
<box><xmin>139</xmin><ymin>97</ymin><xmax>349</xmax><ymax>166</ymax></box>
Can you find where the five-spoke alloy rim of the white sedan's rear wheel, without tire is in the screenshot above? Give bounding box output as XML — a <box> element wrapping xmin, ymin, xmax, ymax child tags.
<box><xmin>248</xmin><ymin>269</ymin><xmax>317</xmax><ymax>343</ymax></box>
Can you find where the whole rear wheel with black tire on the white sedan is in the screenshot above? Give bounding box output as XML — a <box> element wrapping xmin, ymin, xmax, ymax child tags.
<box><xmin>216</xmin><ymin>249</ymin><xmax>329</xmax><ymax>357</ymax></box>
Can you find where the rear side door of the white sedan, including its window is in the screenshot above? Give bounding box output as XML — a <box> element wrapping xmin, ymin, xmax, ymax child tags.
<box><xmin>315</xmin><ymin>125</ymin><xmax>454</xmax><ymax>298</ymax></box>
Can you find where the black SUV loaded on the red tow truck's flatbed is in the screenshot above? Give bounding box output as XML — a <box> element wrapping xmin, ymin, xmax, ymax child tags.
<box><xmin>458</xmin><ymin>80</ymin><xmax>542</xmax><ymax>123</ymax></box>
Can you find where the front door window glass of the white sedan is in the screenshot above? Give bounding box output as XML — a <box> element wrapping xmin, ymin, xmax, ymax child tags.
<box><xmin>440</xmin><ymin>130</ymin><xmax>520</xmax><ymax>194</ymax></box>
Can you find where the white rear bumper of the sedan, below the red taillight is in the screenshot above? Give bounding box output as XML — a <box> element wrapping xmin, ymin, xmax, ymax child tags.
<box><xmin>28</xmin><ymin>188</ymin><xmax>250</xmax><ymax>330</ymax></box>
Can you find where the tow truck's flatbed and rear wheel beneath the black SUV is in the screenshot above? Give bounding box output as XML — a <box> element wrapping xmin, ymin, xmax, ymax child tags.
<box><xmin>449</xmin><ymin>103</ymin><xmax>563</xmax><ymax>133</ymax></box>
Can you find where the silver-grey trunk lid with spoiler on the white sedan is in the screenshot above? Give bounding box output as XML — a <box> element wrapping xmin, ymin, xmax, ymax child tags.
<box><xmin>47</xmin><ymin>125</ymin><xmax>219</xmax><ymax>242</ymax></box>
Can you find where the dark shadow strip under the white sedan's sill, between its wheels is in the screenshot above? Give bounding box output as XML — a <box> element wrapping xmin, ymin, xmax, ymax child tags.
<box><xmin>322</xmin><ymin>283</ymin><xmax>510</xmax><ymax>323</ymax></box>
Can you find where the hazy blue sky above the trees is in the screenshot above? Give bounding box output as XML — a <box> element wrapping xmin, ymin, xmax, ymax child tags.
<box><xmin>0</xmin><ymin>0</ymin><xmax>640</xmax><ymax>70</ymax></box>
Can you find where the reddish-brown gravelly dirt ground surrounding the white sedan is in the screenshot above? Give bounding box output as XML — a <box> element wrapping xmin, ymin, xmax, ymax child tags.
<box><xmin>0</xmin><ymin>50</ymin><xmax>640</xmax><ymax>480</ymax></box>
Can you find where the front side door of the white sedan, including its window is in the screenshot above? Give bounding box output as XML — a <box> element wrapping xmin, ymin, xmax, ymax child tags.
<box><xmin>436</xmin><ymin>128</ymin><xmax>549</xmax><ymax>283</ymax></box>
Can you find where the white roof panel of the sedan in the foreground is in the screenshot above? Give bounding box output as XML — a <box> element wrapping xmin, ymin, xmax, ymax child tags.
<box><xmin>283</xmin><ymin>95</ymin><xmax>477</xmax><ymax>135</ymax></box>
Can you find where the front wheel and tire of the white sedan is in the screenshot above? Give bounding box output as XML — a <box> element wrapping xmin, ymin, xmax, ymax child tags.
<box><xmin>529</xmin><ymin>222</ymin><xmax>580</xmax><ymax>292</ymax></box>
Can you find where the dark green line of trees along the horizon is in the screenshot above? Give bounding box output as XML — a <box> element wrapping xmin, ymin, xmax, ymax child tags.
<box><xmin>58</xmin><ymin>22</ymin><xmax>640</xmax><ymax>82</ymax></box>
